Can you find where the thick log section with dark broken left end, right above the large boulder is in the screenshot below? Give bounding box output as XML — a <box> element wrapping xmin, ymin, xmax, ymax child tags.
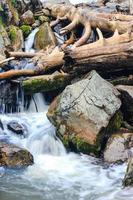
<box><xmin>63</xmin><ymin>41</ymin><xmax>133</xmax><ymax>75</ymax></box>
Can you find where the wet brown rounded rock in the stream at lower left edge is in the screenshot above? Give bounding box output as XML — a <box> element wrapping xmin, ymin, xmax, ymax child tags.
<box><xmin>0</xmin><ymin>143</ymin><xmax>33</xmax><ymax>168</ymax></box>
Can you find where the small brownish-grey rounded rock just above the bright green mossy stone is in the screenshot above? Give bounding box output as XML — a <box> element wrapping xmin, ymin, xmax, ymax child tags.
<box><xmin>21</xmin><ymin>10</ymin><xmax>35</xmax><ymax>25</ymax></box>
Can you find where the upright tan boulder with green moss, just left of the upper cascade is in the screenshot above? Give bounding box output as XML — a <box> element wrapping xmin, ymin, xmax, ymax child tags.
<box><xmin>9</xmin><ymin>25</ymin><xmax>24</xmax><ymax>51</ymax></box>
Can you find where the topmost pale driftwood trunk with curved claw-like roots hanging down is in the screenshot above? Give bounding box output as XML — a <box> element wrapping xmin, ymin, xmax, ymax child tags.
<box><xmin>42</xmin><ymin>3</ymin><xmax>133</xmax><ymax>47</ymax></box>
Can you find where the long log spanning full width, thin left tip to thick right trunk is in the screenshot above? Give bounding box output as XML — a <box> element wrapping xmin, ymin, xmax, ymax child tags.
<box><xmin>0</xmin><ymin>41</ymin><xmax>133</xmax><ymax>79</ymax></box>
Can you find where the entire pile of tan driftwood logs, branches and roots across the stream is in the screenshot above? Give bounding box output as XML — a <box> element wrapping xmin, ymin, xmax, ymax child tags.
<box><xmin>0</xmin><ymin>4</ymin><xmax>133</xmax><ymax>93</ymax></box>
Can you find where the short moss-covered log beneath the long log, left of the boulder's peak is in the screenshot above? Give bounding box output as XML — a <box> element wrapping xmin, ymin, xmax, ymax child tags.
<box><xmin>22</xmin><ymin>73</ymin><xmax>70</xmax><ymax>94</ymax></box>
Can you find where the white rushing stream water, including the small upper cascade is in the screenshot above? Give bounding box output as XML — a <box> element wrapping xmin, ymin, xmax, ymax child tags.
<box><xmin>0</xmin><ymin>1</ymin><xmax>133</xmax><ymax>200</ymax></box>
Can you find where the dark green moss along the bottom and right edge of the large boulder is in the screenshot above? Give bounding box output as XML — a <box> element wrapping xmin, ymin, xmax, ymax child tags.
<box><xmin>57</xmin><ymin>111</ymin><xmax>123</xmax><ymax>156</ymax></box>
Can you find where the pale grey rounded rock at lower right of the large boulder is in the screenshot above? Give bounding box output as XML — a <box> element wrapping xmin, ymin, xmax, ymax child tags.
<box><xmin>104</xmin><ymin>132</ymin><xmax>133</xmax><ymax>163</ymax></box>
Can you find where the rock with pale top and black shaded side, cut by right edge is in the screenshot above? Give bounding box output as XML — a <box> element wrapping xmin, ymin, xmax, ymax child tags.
<box><xmin>116</xmin><ymin>85</ymin><xmax>133</xmax><ymax>124</ymax></box>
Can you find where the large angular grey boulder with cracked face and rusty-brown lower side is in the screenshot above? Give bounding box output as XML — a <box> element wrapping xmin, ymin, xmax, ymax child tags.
<box><xmin>47</xmin><ymin>71</ymin><xmax>122</xmax><ymax>154</ymax></box>
